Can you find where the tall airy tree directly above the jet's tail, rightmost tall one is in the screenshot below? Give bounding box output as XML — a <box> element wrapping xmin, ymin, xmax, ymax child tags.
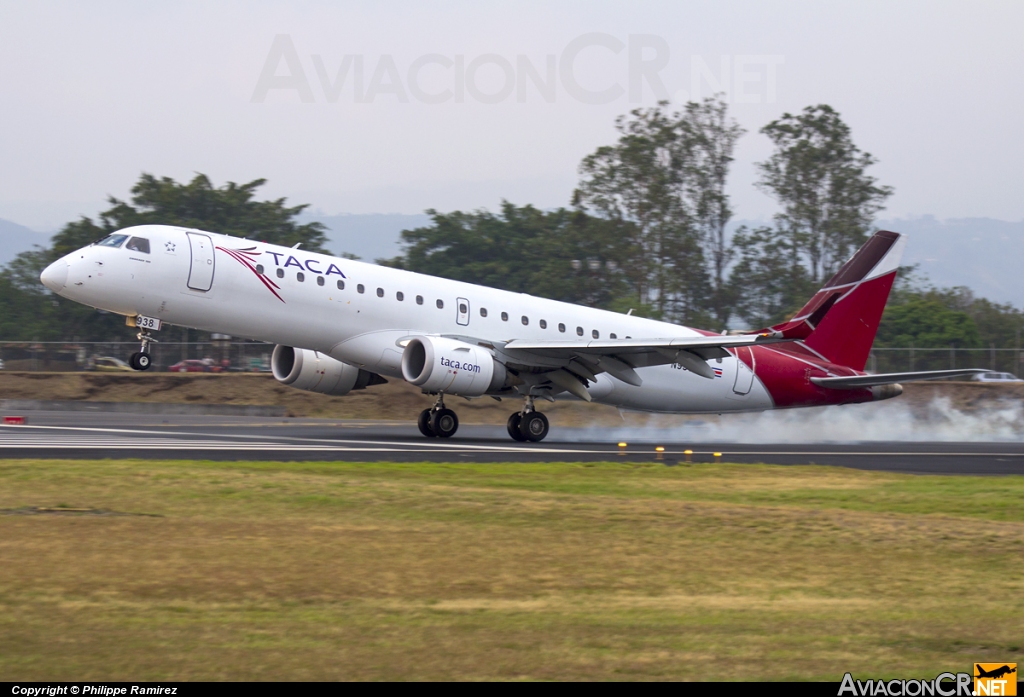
<box><xmin>758</xmin><ymin>104</ymin><xmax>893</xmax><ymax>284</ymax></box>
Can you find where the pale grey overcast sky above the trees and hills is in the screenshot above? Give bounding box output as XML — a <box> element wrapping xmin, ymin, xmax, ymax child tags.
<box><xmin>0</xmin><ymin>0</ymin><xmax>1024</xmax><ymax>229</ymax></box>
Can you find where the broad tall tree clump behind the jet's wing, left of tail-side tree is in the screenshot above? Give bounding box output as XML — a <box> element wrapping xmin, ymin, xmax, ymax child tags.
<box><xmin>573</xmin><ymin>96</ymin><xmax>743</xmax><ymax>329</ymax></box>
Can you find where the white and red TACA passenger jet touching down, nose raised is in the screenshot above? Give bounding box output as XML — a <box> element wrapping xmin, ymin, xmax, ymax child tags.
<box><xmin>40</xmin><ymin>225</ymin><xmax>985</xmax><ymax>442</ymax></box>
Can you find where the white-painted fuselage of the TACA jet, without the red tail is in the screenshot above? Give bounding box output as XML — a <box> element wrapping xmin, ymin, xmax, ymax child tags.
<box><xmin>44</xmin><ymin>225</ymin><xmax>773</xmax><ymax>412</ymax></box>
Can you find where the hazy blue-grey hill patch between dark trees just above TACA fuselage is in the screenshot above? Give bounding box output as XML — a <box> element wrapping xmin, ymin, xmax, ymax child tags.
<box><xmin>302</xmin><ymin>213</ymin><xmax>430</xmax><ymax>261</ymax></box>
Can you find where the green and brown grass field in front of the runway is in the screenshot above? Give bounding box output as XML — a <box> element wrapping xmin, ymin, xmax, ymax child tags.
<box><xmin>0</xmin><ymin>461</ymin><xmax>1024</xmax><ymax>681</ymax></box>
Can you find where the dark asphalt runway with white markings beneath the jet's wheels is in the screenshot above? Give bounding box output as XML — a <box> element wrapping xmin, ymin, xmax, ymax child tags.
<box><xmin>0</xmin><ymin>411</ymin><xmax>1024</xmax><ymax>475</ymax></box>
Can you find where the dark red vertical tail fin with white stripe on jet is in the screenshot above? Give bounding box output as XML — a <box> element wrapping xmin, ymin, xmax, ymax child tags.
<box><xmin>771</xmin><ymin>230</ymin><xmax>906</xmax><ymax>371</ymax></box>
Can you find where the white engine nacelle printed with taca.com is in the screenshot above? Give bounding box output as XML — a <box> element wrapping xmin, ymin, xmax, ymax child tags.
<box><xmin>401</xmin><ymin>337</ymin><xmax>507</xmax><ymax>397</ymax></box>
